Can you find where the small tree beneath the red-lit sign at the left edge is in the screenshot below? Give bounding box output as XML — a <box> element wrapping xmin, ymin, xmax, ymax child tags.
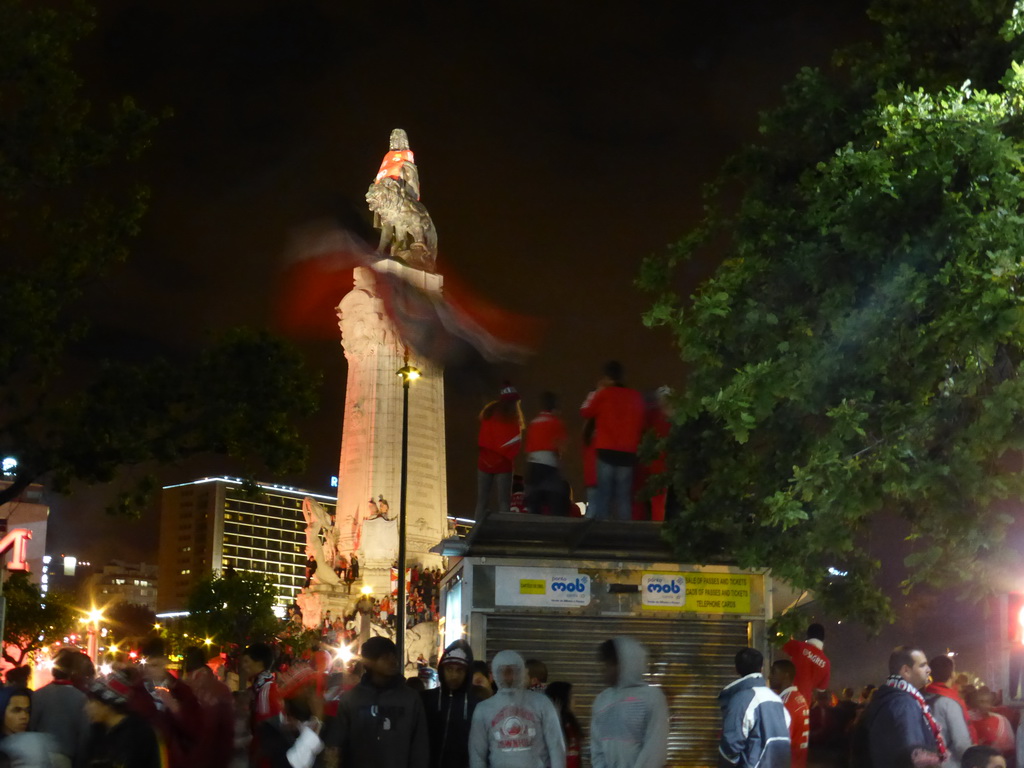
<box><xmin>3</xmin><ymin>573</ymin><xmax>74</xmax><ymax>667</ymax></box>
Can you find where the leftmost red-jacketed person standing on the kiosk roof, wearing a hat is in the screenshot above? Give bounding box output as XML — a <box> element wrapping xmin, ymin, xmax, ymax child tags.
<box><xmin>475</xmin><ymin>382</ymin><xmax>525</xmax><ymax>520</ymax></box>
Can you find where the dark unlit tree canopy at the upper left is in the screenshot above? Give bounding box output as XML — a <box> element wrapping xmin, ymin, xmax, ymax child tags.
<box><xmin>0</xmin><ymin>0</ymin><xmax>315</xmax><ymax>512</ymax></box>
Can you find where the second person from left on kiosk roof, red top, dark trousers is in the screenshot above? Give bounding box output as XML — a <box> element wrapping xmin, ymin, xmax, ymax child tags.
<box><xmin>526</xmin><ymin>392</ymin><xmax>569</xmax><ymax>515</ymax></box>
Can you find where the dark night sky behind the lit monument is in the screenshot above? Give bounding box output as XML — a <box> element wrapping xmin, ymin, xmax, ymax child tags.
<box><xmin>41</xmin><ymin>0</ymin><xmax>983</xmax><ymax>682</ymax></box>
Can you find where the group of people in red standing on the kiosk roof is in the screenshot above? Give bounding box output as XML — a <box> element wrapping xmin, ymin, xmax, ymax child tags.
<box><xmin>475</xmin><ymin>360</ymin><xmax>673</xmax><ymax>520</ymax></box>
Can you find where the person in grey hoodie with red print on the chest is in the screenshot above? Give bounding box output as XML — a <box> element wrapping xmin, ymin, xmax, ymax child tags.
<box><xmin>469</xmin><ymin>650</ymin><xmax>565</xmax><ymax>768</ymax></box>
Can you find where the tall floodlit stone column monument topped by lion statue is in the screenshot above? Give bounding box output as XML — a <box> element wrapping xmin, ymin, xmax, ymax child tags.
<box><xmin>335</xmin><ymin>129</ymin><xmax>447</xmax><ymax>596</ymax></box>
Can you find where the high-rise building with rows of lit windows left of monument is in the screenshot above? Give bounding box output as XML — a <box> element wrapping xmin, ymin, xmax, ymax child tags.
<box><xmin>158</xmin><ymin>477</ymin><xmax>336</xmax><ymax>611</ymax></box>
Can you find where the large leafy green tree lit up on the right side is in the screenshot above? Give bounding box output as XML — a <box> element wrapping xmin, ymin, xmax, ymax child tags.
<box><xmin>640</xmin><ymin>0</ymin><xmax>1024</xmax><ymax>628</ymax></box>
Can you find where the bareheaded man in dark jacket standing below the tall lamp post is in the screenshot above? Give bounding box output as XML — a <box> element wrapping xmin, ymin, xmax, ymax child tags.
<box><xmin>324</xmin><ymin>636</ymin><xmax>430</xmax><ymax>768</ymax></box>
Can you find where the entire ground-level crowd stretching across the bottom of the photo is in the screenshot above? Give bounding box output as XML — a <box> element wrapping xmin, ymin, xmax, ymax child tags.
<box><xmin>0</xmin><ymin>625</ymin><xmax>1024</xmax><ymax>768</ymax></box>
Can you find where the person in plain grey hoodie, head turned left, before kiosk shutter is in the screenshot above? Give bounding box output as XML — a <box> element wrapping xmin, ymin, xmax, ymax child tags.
<box><xmin>590</xmin><ymin>637</ymin><xmax>669</xmax><ymax>768</ymax></box>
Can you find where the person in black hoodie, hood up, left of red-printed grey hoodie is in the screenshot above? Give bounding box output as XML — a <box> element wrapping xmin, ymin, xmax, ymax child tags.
<box><xmin>423</xmin><ymin>640</ymin><xmax>477</xmax><ymax>768</ymax></box>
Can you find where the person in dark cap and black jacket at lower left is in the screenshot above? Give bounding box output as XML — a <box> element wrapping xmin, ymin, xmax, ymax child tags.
<box><xmin>85</xmin><ymin>673</ymin><xmax>165</xmax><ymax>768</ymax></box>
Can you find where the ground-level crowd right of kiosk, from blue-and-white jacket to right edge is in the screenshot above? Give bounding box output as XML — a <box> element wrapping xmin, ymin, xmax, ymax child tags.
<box><xmin>720</xmin><ymin>624</ymin><xmax>1024</xmax><ymax>768</ymax></box>
